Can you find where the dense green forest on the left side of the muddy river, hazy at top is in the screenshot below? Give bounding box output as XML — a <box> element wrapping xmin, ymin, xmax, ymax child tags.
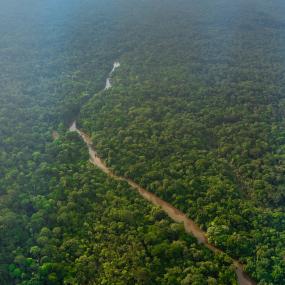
<box><xmin>0</xmin><ymin>0</ymin><xmax>240</xmax><ymax>285</ymax></box>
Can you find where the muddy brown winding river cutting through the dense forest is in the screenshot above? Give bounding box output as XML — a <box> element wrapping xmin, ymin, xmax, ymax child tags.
<box><xmin>69</xmin><ymin>62</ymin><xmax>256</xmax><ymax>285</ymax></box>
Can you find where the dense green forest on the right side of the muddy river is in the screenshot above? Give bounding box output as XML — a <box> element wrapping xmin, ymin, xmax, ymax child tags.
<box><xmin>77</xmin><ymin>0</ymin><xmax>285</xmax><ymax>285</ymax></box>
